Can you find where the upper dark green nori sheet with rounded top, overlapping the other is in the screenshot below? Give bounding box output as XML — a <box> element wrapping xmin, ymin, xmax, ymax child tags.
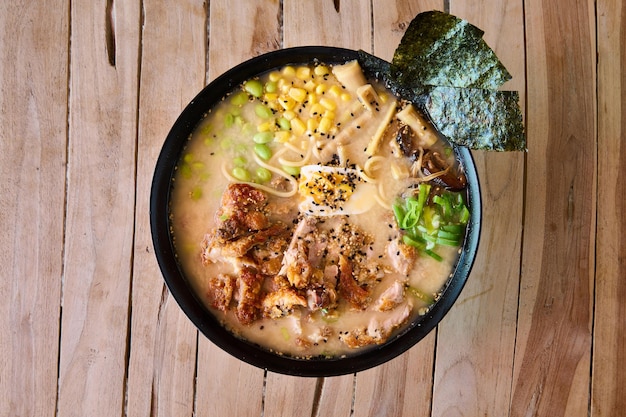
<box><xmin>391</xmin><ymin>11</ymin><xmax>511</xmax><ymax>90</ymax></box>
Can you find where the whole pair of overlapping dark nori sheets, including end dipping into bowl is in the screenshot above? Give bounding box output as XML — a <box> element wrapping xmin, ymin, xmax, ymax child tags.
<box><xmin>359</xmin><ymin>11</ymin><xmax>526</xmax><ymax>151</ymax></box>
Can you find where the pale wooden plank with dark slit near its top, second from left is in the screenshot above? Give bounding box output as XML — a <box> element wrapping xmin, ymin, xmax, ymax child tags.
<box><xmin>58</xmin><ymin>1</ymin><xmax>141</xmax><ymax>416</ymax></box>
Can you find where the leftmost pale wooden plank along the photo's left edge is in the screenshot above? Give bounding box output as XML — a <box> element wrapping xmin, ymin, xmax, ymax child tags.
<box><xmin>0</xmin><ymin>1</ymin><xmax>69</xmax><ymax>416</ymax></box>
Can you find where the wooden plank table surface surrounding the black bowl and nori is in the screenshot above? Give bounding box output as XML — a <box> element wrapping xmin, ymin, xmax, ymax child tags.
<box><xmin>0</xmin><ymin>0</ymin><xmax>626</xmax><ymax>417</ymax></box>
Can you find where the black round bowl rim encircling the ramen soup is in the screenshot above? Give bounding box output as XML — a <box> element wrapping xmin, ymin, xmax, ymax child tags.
<box><xmin>150</xmin><ymin>46</ymin><xmax>481</xmax><ymax>376</ymax></box>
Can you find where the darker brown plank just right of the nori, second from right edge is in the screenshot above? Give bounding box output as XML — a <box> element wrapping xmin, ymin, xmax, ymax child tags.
<box><xmin>511</xmin><ymin>0</ymin><xmax>597</xmax><ymax>416</ymax></box>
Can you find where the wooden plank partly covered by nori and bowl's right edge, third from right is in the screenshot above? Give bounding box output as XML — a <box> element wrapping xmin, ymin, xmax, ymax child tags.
<box><xmin>433</xmin><ymin>0</ymin><xmax>525</xmax><ymax>416</ymax></box>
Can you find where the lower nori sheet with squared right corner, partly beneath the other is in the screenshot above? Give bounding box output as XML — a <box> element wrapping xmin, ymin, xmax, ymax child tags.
<box><xmin>424</xmin><ymin>87</ymin><xmax>526</xmax><ymax>151</ymax></box>
